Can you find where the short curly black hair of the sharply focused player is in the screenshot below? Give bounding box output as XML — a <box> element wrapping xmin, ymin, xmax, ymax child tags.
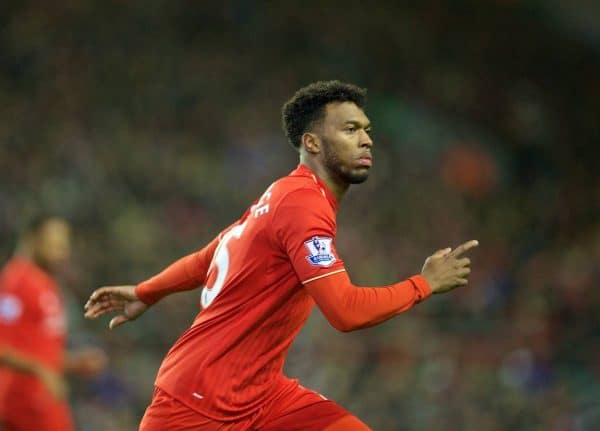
<box><xmin>281</xmin><ymin>81</ymin><xmax>367</xmax><ymax>149</ymax></box>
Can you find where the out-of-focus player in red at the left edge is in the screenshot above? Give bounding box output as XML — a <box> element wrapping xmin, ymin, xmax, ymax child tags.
<box><xmin>0</xmin><ymin>216</ymin><xmax>106</xmax><ymax>431</ymax></box>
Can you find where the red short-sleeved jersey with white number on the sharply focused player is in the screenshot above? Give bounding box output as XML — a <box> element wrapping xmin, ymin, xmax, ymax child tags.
<box><xmin>156</xmin><ymin>165</ymin><xmax>345</xmax><ymax>420</ymax></box>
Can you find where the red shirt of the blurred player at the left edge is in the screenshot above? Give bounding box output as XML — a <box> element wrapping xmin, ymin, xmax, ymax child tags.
<box><xmin>0</xmin><ymin>257</ymin><xmax>66</xmax><ymax>404</ymax></box>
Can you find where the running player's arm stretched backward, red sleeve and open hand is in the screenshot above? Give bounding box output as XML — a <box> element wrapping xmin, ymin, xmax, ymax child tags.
<box><xmin>85</xmin><ymin>236</ymin><xmax>220</xmax><ymax>329</ymax></box>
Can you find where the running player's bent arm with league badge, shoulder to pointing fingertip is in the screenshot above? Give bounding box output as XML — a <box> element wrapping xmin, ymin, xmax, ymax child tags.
<box><xmin>272</xmin><ymin>189</ymin><xmax>477</xmax><ymax>332</ymax></box>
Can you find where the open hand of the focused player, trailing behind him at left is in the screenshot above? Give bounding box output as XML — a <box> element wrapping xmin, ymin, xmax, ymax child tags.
<box><xmin>84</xmin><ymin>286</ymin><xmax>148</xmax><ymax>329</ymax></box>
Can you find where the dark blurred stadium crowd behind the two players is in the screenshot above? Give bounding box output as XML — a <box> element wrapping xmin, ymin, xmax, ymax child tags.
<box><xmin>0</xmin><ymin>0</ymin><xmax>600</xmax><ymax>431</ymax></box>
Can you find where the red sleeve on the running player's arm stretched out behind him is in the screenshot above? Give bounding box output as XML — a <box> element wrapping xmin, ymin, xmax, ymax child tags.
<box><xmin>135</xmin><ymin>235</ymin><xmax>220</xmax><ymax>305</ymax></box>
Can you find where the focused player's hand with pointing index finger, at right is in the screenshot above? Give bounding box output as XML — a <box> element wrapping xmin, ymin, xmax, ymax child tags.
<box><xmin>421</xmin><ymin>240</ymin><xmax>479</xmax><ymax>293</ymax></box>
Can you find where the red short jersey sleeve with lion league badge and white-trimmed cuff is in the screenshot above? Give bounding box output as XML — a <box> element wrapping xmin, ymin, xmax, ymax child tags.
<box><xmin>273</xmin><ymin>188</ymin><xmax>345</xmax><ymax>283</ymax></box>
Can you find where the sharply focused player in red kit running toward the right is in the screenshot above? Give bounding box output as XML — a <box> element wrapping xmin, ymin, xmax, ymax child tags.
<box><xmin>86</xmin><ymin>81</ymin><xmax>477</xmax><ymax>431</ymax></box>
